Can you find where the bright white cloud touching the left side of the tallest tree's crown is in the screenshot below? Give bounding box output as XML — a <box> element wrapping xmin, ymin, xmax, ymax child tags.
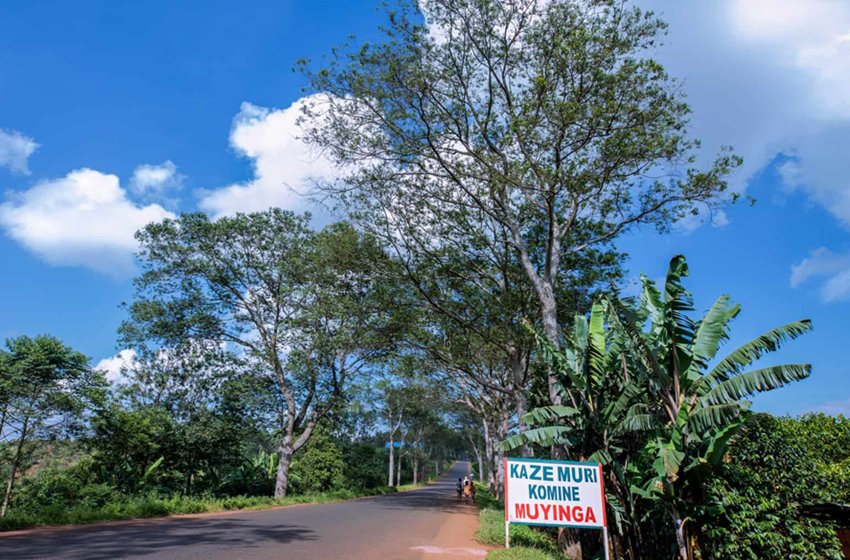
<box><xmin>199</xmin><ymin>98</ymin><xmax>333</xmax><ymax>217</ymax></box>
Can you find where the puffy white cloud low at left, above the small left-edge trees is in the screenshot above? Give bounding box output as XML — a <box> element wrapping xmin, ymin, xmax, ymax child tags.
<box><xmin>0</xmin><ymin>169</ymin><xmax>174</xmax><ymax>278</ymax></box>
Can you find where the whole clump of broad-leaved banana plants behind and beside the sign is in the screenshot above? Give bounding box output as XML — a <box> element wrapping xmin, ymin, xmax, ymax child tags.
<box><xmin>502</xmin><ymin>255</ymin><xmax>816</xmax><ymax>560</ymax></box>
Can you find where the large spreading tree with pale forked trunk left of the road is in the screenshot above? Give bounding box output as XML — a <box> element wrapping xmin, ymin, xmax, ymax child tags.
<box><xmin>121</xmin><ymin>209</ymin><xmax>394</xmax><ymax>497</ymax></box>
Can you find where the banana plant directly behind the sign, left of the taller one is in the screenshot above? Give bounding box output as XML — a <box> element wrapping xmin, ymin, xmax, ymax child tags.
<box><xmin>501</xmin><ymin>301</ymin><xmax>647</xmax><ymax>557</ymax></box>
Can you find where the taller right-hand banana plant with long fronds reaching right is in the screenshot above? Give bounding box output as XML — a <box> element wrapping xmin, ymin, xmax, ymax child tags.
<box><xmin>613</xmin><ymin>255</ymin><xmax>812</xmax><ymax>560</ymax></box>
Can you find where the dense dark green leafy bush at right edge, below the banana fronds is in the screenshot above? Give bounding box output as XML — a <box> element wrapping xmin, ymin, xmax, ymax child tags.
<box><xmin>697</xmin><ymin>414</ymin><xmax>850</xmax><ymax>560</ymax></box>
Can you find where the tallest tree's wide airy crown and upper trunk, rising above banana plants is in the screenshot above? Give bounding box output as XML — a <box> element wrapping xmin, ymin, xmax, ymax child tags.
<box><xmin>299</xmin><ymin>0</ymin><xmax>739</xmax><ymax>404</ymax></box>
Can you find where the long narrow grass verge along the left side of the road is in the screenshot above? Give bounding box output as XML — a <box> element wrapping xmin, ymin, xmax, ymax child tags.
<box><xmin>0</xmin><ymin>484</ymin><xmax>400</xmax><ymax>531</ymax></box>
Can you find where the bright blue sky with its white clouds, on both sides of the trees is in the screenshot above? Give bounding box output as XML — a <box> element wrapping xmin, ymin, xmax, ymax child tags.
<box><xmin>0</xmin><ymin>0</ymin><xmax>850</xmax><ymax>414</ymax></box>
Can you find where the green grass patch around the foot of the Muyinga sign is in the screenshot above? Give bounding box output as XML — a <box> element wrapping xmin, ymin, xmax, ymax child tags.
<box><xmin>475</xmin><ymin>483</ymin><xmax>567</xmax><ymax>560</ymax></box>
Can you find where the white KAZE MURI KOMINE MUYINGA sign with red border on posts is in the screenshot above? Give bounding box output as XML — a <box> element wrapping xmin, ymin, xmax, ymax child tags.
<box><xmin>505</xmin><ymin>457</ymin><xmax>608</xmax><ymax>560</ymax></box>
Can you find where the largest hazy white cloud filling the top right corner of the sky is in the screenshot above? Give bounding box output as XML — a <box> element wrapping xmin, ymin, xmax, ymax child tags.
<box><xmin>638</xmin><ymin>0</ymin><xmax>850</xmax><ymax>237</ymax></box>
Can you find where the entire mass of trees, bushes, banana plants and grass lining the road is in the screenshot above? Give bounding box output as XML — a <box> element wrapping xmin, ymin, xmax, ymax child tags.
<box><xmin>0</xmin><ymin>0</ymin><xmax>850</xmax><ymax>560</ymax></box>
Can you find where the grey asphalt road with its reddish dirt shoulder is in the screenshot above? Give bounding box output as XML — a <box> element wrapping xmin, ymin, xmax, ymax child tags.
<box><xmin>0</xmin><ymin>462</ymin><xmax>487</xmax><ymax>560</ymax></box>
